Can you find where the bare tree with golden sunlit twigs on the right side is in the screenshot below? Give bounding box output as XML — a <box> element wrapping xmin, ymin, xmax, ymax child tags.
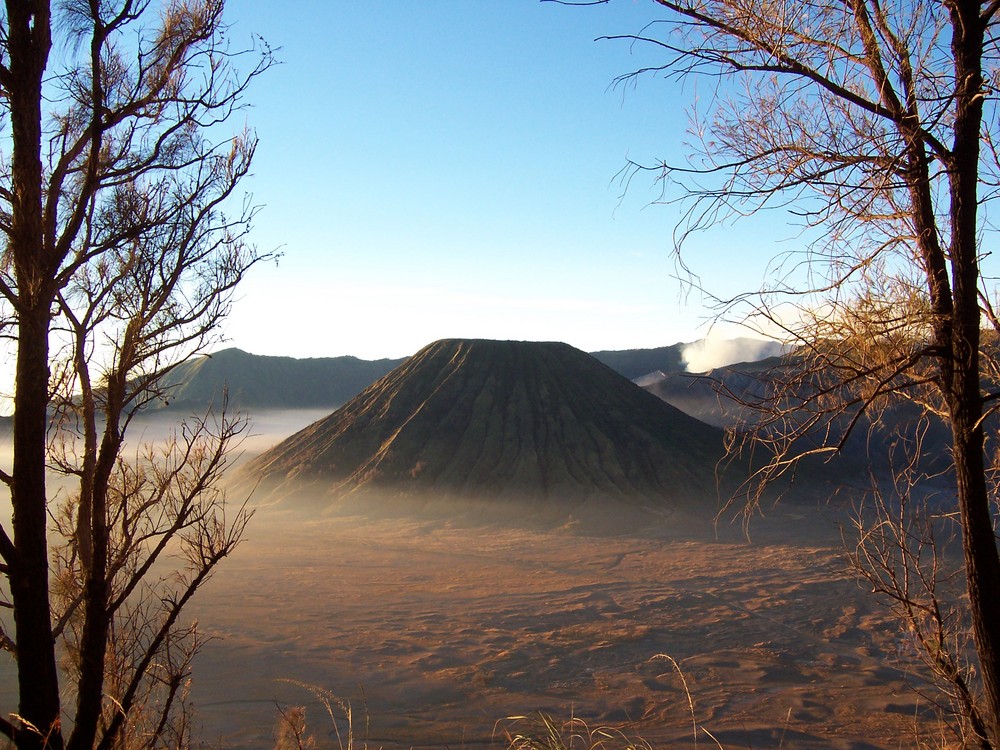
<box><xmin>557</xmin><ymin>0</ymin><xmax>1000</xmax><ymax>747</ymax></box>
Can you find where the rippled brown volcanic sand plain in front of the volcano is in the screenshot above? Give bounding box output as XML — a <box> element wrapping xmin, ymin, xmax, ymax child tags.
<box><xmin>186</xmin><ymin>511</ymin><xmax>936</xmax><ymax>749</ymax></box>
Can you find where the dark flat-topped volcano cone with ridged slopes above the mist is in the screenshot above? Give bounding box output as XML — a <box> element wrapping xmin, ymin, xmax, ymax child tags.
<box><xmin>243</xmin><ymin>340</ymin><xmax>736</xmax><ymax>524</ymax></box>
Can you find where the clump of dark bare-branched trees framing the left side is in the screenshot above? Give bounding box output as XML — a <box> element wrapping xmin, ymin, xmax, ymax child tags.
<box><xmin>0</xmin><ymin>0</ymin><xmax>272</xmax><ymax>749</ymax></box>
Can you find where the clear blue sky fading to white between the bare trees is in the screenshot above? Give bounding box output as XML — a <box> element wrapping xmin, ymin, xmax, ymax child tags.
<box><xmin>217</xmin><ymin>0</ymin><xmax>790</xmax><ymax>359</ymax></box>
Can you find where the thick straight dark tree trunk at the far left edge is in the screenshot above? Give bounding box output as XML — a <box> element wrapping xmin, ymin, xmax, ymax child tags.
<box><xmin>7</xmin><ymin>0</ymin><xmax>63</xmax><ymax>750</ymax></box>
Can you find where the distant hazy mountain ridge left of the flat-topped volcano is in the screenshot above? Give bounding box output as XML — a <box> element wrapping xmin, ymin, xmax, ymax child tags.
<box><xmin>157</xmin><ymin>349</ymin><xmax>403</xmax><ymax>411</ymax></box>
